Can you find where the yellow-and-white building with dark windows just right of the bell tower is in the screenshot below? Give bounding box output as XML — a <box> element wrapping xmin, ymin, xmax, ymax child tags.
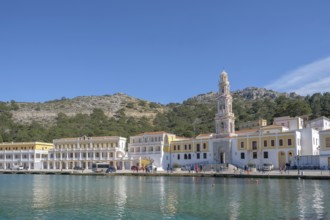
<box><xmin>233</xmin><ymin>125</ymin><xmax>301</xmax><ymax>168</ymax></box>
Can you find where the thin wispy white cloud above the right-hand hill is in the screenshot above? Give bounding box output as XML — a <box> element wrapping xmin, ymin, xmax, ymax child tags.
<box><xmin>265</xmin><ymin>57</ymin><xmax>330</xmax><ymax>95</ymax></box>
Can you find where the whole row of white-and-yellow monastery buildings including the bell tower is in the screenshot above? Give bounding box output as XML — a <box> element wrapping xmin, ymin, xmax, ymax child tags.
<box><xmin>0</xmin><ymin>71</ymin><xmax>330</xmax><ymax>170</ymax></box>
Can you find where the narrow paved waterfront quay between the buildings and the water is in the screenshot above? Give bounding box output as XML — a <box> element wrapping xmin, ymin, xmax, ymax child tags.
<box><xmin>0</xmin><ymin>170</ymin><xmax>330</xmax><ymax>180</ymax></box>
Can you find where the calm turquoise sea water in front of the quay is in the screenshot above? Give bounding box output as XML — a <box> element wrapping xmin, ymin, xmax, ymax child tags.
<box><xmin>0</xmin><ymin>174</ymin><xmax>330</xmax><ymax>219</ymax></box>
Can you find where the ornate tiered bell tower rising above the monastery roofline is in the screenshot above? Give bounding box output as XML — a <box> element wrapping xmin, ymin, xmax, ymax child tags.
<box><xmin>215</xmin><ymin>70</ymin><xmax>235</xmax><ymax>137</ymax></box>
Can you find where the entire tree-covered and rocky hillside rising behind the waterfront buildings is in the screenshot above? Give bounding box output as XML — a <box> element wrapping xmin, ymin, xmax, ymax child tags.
<box><xmin>0</xmin><ymin>87</ymin><xmax>330</xmax><ymax>142</ymax></box>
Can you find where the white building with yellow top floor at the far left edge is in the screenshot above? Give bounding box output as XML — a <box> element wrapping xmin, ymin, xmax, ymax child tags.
<box><xmin>0</xmin><ymin>142</ymin><xmax>53</xmax><ymax>169</ymax></box>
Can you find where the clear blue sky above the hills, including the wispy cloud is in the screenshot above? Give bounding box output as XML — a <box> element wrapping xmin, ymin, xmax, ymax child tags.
<box><xmin>0</xmin><ymin>0</ymin><xmax>330</xmax><ymax>104</ymax></box>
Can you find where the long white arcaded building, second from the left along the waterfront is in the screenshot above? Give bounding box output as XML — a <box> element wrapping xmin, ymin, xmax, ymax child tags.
<box><xmin>44</xmin><ymin>136</ymin><xmax>131</xmax><ymax>170</ymax></box>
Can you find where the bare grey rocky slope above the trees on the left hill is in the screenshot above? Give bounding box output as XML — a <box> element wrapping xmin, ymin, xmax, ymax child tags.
<box><xmin>11</xmin><ymin>93</ymin><xmax>167</xmax><ymax>124</ymax></box>
